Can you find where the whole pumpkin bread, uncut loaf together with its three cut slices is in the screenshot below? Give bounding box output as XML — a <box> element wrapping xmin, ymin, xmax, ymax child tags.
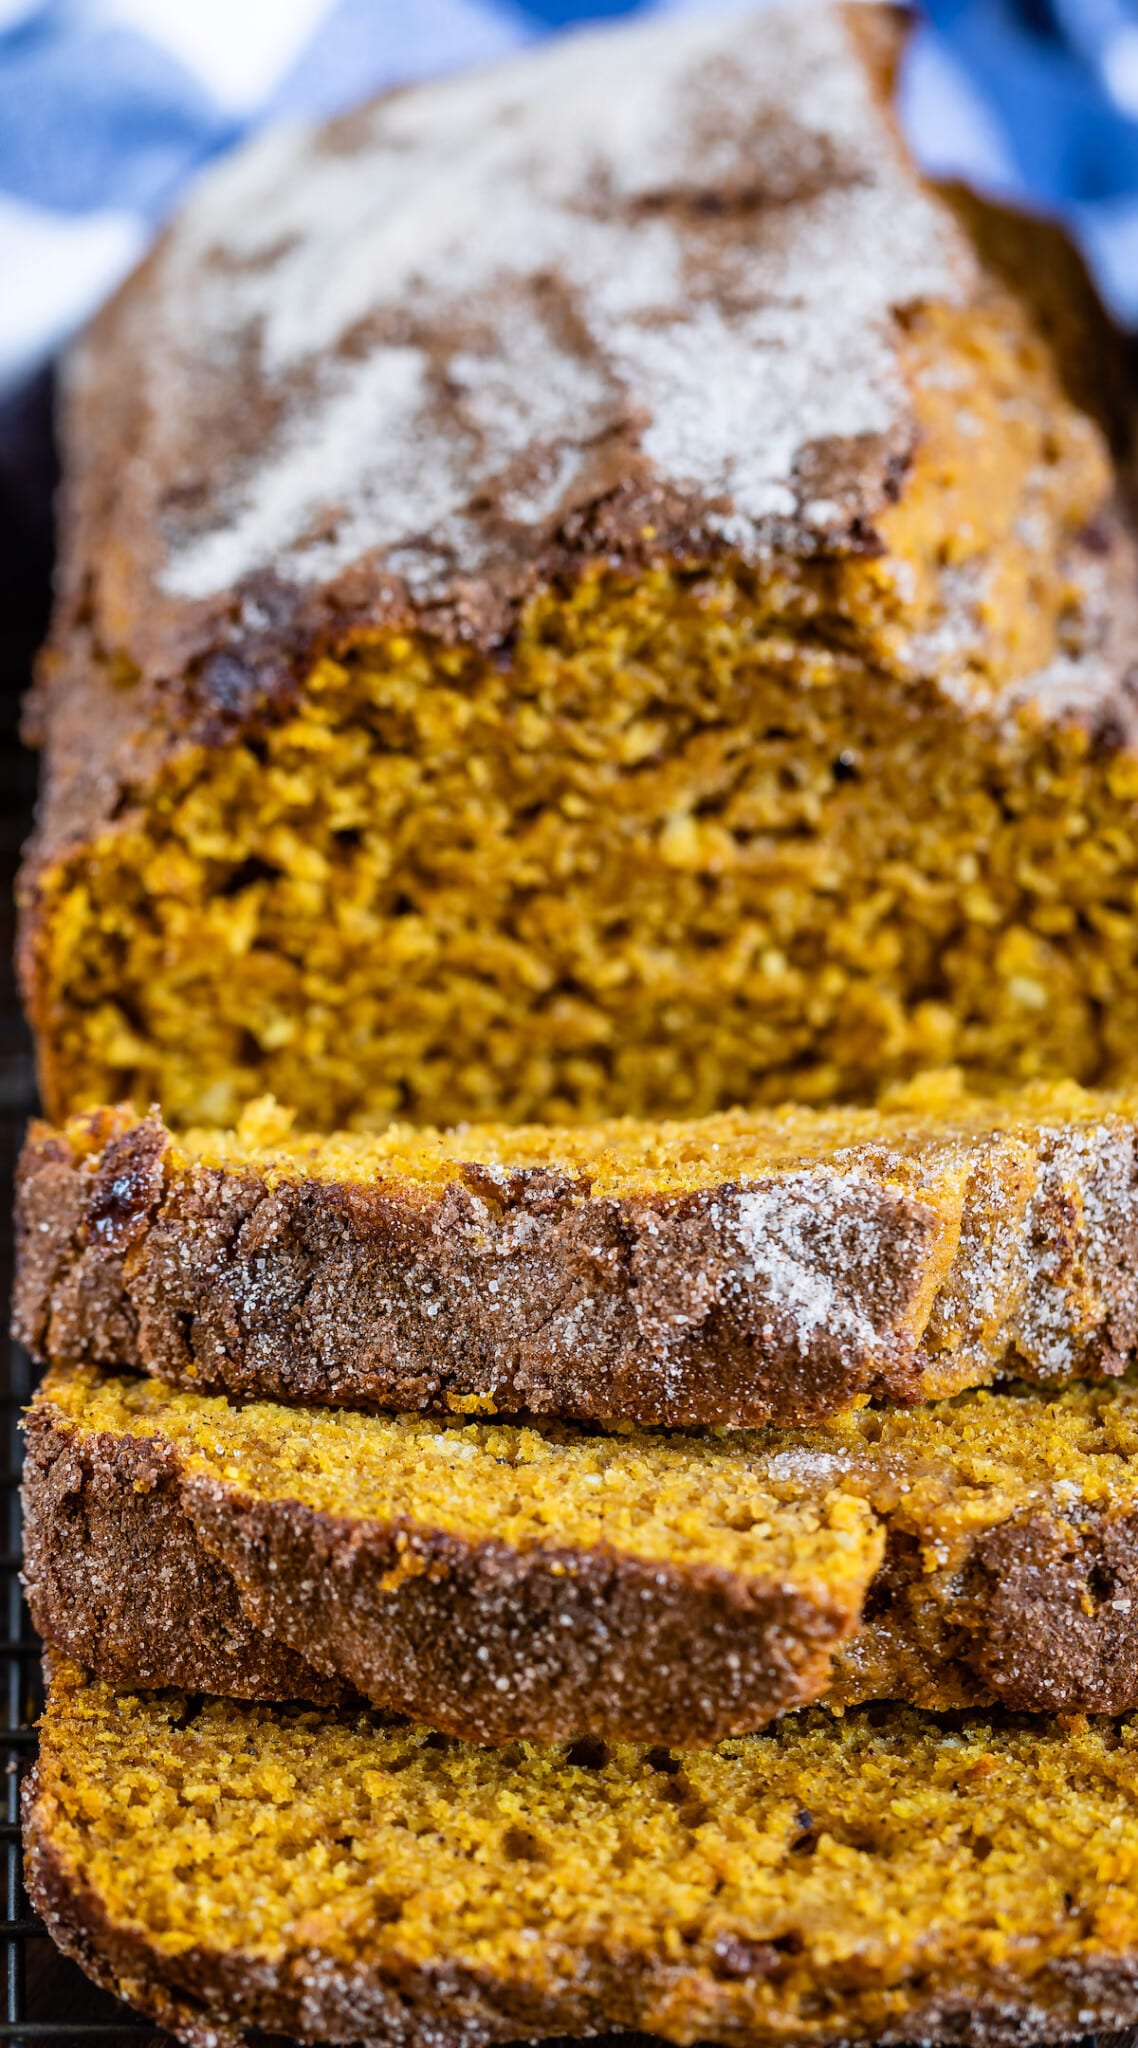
<box><xmin>16</xmin><ymin>0</ymin><xmax>1138</xmax><ymax>2048</ymax></box>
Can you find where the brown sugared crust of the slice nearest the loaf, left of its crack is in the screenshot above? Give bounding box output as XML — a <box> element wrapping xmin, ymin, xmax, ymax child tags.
<box><xmin>14</xmin><ymin>1112</ymin><xmax>944</xmax><ymax>1425</ymax></box>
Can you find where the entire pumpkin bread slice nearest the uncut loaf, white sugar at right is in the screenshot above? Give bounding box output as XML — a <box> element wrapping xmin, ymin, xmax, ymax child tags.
<box><xmin>16</xmin><ymin>1077</ymin><xmax>1138</xmax><ymax>1425</ymax></box>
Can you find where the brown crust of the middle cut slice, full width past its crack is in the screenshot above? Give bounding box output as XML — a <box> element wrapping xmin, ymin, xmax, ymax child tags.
<box><xmin>25</xmin><ymin>1395</ymin><xmax>1138</xmax><ymax>1747</ymax></box>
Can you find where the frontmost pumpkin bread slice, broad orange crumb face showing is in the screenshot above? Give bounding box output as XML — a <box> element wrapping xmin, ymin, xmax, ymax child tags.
<box><xmin>25</xmin><ymin>1665</ymin><xmax>1138</xmax><ymax>2048</ymax></box>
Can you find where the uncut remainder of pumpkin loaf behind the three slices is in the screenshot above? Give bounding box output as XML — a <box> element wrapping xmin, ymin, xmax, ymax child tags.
<box><xmin>23</xmin><ymin>0</ymin><xmax>1138</xmax><ymax>1130</ymax></box>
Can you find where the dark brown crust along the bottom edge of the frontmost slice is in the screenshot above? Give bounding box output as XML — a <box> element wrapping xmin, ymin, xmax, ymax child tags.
<box><xmin>23</xmin><ymin>1767</ymin><xmax>1138</xmax><ymax>2048</ymax></box>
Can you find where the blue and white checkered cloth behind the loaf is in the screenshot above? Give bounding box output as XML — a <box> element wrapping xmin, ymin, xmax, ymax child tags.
<box><xmin>0</xmin><ymin>0</ymin><xmax>1138</xmax><ymax>391</ymax></box>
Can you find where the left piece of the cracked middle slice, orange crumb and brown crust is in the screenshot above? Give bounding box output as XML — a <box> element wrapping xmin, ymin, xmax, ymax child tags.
<box><xmin>25</xmin><ymin>1368</ymin><xmax>884</xmax><ymax>1743</ymax></box>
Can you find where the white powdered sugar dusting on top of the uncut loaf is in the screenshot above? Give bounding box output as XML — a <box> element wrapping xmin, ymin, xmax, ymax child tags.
<box><xmin>128</xmin><ymin>0</ymin><xmax>972</xmax><ymax>598</ymax></box>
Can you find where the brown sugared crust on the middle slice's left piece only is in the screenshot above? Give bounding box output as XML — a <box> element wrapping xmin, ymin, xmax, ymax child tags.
<box><xmin>25</xmin><ymin>1399</ymin><xmax>858</xmax><ymax>1747</ymax></box>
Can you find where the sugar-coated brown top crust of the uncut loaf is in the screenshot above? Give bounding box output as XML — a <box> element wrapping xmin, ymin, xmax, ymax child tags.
<box><xmin>48</xmin><ymin>0</ymin><xmax>966</xmax><ymax>674</ymax></box>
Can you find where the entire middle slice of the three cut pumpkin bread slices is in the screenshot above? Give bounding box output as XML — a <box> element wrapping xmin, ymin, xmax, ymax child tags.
<box><xmin>25</xmin><ymin>1368</ymin><xmax>1138</xmax><ymax>1745</ymax></box>
